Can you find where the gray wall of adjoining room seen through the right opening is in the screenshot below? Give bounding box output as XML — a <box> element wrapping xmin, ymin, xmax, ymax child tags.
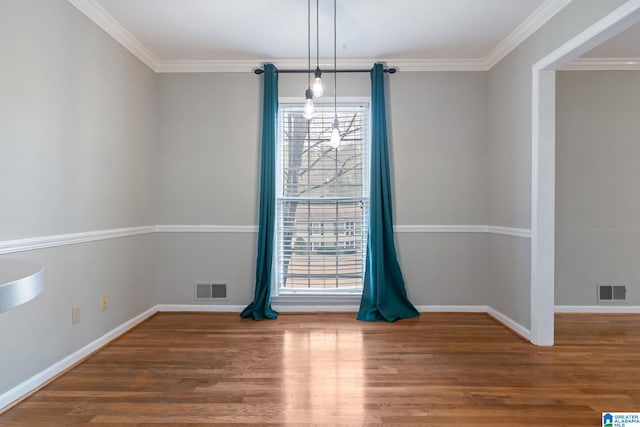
<box><xmin>556</xmin><ymin>71</ymin><xmax>640</xmax><ymax>305</ymax></box>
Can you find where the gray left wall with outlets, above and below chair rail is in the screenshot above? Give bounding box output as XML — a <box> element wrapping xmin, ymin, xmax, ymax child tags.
<box><xmin>0</xmin><ymin>0</ymin><xmax>156</xmax><ymax>394</ymax></box>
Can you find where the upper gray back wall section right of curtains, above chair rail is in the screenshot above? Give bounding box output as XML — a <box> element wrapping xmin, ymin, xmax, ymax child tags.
<box><xmin>388</xmin><ymin>71</ymin><xmax>488</xmax><ymax>224</ymax></box>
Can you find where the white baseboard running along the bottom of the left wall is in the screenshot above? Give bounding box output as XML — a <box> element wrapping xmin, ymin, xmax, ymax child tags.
<box><xmin>0</xmin><ymin>306</ymin><xmax>158</xmax><ymax>413</ymax></box>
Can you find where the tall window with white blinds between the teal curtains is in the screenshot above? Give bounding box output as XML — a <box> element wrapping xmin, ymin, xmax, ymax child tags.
<box><xmin>274</xmin><ymin>102</ymin><xmax>369</xmax><ymax>295</ymax></box>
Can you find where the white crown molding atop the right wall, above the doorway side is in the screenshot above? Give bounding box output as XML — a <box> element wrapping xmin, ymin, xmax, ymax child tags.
<box><xmin>485</xmin><ymin>0</ymin><xmax>573</xmax><ymax>70</ymax></box>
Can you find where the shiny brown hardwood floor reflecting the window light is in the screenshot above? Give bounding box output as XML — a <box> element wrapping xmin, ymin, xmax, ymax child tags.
<box><xmin>0</xmin><ymin>313</ymin><xmax>640</xmax><ymax>427</ymax></box>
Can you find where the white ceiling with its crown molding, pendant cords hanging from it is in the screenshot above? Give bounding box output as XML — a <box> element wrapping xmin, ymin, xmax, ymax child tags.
<box><xmin>68</xmin><ymin>0</ymin><xmax>571</xmax><ymax>71</ymax></box>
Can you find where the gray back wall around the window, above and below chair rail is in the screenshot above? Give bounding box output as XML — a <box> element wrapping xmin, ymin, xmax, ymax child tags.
<box><xmin>156</xmin><ymin>72</ymin><xmax>488</xmax><ymax>305</ymax></box>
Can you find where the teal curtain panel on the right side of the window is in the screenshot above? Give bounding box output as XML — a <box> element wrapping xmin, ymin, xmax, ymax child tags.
<box><xmin>358</xmin><ymin>64</ymin><xmax>419</xmax><ymax>322</ymax></box>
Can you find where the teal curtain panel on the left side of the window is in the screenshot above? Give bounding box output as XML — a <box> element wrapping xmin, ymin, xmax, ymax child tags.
<box><xmin>240</xmin><ymin>64</ymin><xmax>278</xmax><ymax>320</ymax></box>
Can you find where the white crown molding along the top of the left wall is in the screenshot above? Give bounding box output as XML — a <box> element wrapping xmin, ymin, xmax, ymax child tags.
<box><xmin>67</xmin><ymin>0</ymin><xmax>158</xmax><ymax>71</ymax></box>
